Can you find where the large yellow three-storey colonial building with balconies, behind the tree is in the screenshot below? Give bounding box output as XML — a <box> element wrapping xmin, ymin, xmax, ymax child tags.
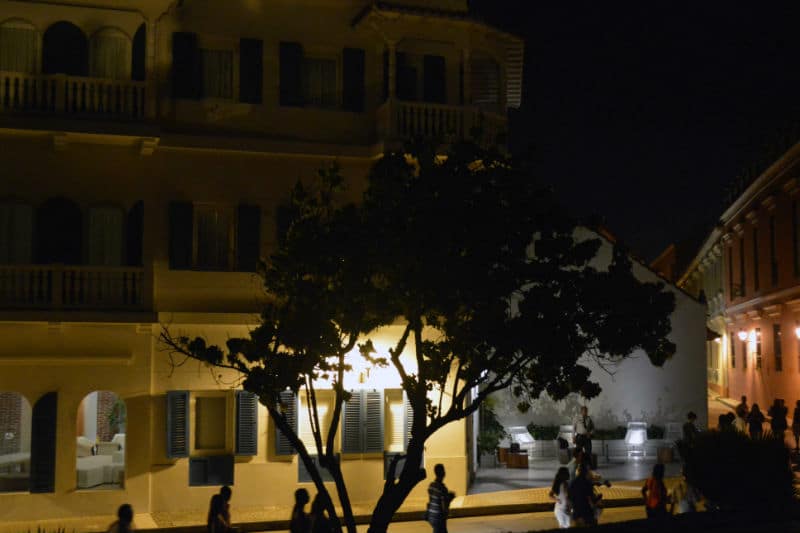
<box><xmin>0</xmin><ymin>0</ymin><xmax>522</xmax><ymax>525</ymax></box>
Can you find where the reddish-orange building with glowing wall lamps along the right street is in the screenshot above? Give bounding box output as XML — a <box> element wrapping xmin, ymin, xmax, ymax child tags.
<box><xmin>677</xmin><ymin>143</ymin><xmax>800</xmax><ymax>407</ymax></box>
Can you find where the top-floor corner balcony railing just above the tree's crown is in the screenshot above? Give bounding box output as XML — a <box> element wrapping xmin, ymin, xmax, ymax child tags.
<box><xmin>377</xmin><ymin>99</ymin><xmax>508</xmax><ymax>145</ymax></box>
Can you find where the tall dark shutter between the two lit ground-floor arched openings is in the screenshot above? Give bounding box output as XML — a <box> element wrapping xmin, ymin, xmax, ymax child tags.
<box><xmin>30</xmin><ymin>392</ymin><xmax>58</xmax><ymax>493</ymax></box>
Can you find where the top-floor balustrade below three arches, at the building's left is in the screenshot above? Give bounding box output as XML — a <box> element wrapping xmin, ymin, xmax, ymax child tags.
<box><xmin>0</xmin><ymin>71</ymin><xmax>145</xmax><ymax>119</ymax></box>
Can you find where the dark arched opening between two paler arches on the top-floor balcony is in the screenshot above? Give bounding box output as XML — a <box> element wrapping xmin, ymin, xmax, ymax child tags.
<box><xmin>42</xmin><ymin>21</ymin><xmax>89</xmax><ymax>76</ymax></box>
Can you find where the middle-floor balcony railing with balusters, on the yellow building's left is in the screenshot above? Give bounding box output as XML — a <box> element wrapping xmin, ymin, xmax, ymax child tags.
<box><xmin>0</xmin><ymin>265</ymin><xmax>144</xmax><ymax>311</ymax></box>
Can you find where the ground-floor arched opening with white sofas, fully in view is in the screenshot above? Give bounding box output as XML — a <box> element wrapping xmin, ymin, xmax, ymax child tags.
<box><xmin>75</xmin><ymin>391</ymin><xmax>127</xmax><ymax>489</ymax></box>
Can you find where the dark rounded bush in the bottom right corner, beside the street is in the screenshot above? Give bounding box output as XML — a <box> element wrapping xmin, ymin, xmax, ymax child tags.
<box><xmin>681</xmin><ymin>430</ymin><xmax>796</xmax><ymax>512</ymax></box>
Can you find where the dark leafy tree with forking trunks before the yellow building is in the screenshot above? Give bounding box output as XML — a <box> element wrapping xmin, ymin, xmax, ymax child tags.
<box><xmin>162</xmin><ymin>144</ymin><xmax>675</xmax><ymax>532</ymax></box>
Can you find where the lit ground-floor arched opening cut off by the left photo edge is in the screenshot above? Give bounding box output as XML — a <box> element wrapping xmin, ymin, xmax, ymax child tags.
<box><xmin>0</xmin><ymin>392</ymin><xmax>31</xmax><ymax>492</ymax></box>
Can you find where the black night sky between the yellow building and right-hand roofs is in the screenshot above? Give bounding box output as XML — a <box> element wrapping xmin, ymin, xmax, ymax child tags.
<box><xmin>471</xmin><ymin>0</ymin><xmax>800</xmax><ymax>260</ymax></box>
